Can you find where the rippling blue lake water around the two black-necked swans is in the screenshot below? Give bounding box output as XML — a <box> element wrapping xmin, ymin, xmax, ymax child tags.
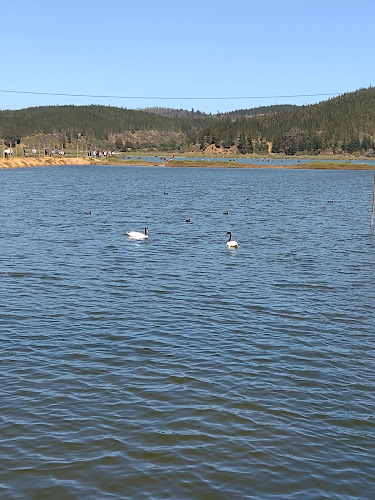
<box><xmin>0</xmin><ymin>166</ymin><xmax>375</xmax><ymax>500</ymax></box>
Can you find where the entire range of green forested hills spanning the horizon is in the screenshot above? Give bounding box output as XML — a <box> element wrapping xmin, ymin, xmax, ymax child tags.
<box><xmin>0</xmin><ymin>87</ymin><xmax>375</xmax><ymax>156</ymax></box>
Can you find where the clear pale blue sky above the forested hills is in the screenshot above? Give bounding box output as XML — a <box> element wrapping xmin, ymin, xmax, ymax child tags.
<box><xmin>0</xmin><ymin>0</ymin><xmax>375</xmax><ymax>113</ymax></box>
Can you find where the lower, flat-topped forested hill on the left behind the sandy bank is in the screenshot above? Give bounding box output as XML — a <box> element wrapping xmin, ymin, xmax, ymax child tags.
<box><xmin>0</xmin><ymin>106</ymin><xmax>211</xmax><ymax>149</ymax></box>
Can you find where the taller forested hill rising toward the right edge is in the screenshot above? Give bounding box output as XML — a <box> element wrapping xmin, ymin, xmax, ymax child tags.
<box><xmin>198</xmin><ymin>87</ymin><xmax>375</xmax><ymax>156</ymax></box>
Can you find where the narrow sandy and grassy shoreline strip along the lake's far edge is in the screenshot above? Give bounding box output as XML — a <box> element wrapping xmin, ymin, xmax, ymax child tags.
<box><xmin>0</xmin><ymin>156</ymin><xmax>375</xmax><ymax>170</ymax></box>
